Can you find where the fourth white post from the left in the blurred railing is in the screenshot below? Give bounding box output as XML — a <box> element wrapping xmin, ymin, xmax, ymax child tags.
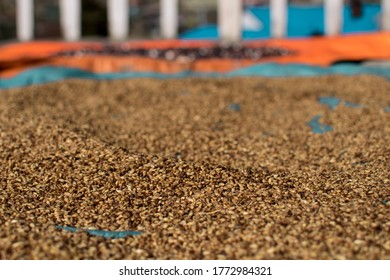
<box><xmin>160</xmin><ymin>0</ymin><xmax>179</xmax><ymax>39</ymax></box>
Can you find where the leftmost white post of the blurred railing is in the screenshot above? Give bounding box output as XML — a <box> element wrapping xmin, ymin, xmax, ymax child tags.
<box><xmin>16</xmin><ymin>0</ymin><xmax>34</xmax><ymax>41</ymax></box>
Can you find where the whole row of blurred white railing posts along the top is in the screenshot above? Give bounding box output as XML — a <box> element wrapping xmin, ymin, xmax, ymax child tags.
<box><xmin>16</xmin><ymin>0</ymin><xmax>390</xmax><ymax>42</ymax></box>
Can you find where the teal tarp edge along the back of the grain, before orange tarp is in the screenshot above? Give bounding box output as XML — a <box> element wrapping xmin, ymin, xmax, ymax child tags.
<box><xmin>0</xmin><ymin>63</ymin><xmax>390</xmax><ymax>88</ymax></box>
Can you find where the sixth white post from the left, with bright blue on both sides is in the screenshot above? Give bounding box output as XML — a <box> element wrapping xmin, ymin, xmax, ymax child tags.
<box><xmin>270</xmin><ymin>0</ymin><xmax>288</xmax><ymax>38</ymax></box>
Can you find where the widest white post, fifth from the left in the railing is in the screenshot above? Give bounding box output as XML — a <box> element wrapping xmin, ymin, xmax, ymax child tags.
<box><xmin>218</xmin><ymin>0</ymin><xmax>242</xmax><ymax>42</ymax></box>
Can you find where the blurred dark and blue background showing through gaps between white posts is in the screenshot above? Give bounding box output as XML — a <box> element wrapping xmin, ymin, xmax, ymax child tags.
<box><xmin>0</xmin><ymin>0</ymin><xmax>380</xmax><ymax>40</ymax></box>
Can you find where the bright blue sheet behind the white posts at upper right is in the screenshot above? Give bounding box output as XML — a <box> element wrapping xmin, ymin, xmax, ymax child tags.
<box><xmin>180</xmin><ymin>4</ymin><xmax>380</xmax><ymax>39</ymax></box>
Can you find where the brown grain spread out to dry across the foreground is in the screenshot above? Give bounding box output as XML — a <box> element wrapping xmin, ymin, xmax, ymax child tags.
<box><xmin>0</xmin><ymin>76</ymin><xmax>390</xmax><ymax>259</ymax></box>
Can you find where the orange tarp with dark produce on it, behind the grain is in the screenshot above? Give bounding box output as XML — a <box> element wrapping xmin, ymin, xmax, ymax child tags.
<box><xmin>0</xmin><ymin>32</ymin><xmax>390</xmax><ymax>77</ymax></box>
